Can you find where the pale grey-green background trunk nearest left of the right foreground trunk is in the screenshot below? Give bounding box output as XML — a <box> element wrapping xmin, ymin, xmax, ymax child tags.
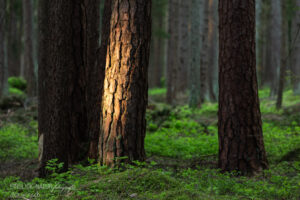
<box><xmin>189</xmin><ymin>0</ymin><xmax>202</xmax><ymax>107</ymax></box>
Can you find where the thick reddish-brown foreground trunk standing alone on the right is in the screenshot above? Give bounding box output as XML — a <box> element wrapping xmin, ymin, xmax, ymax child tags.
<box><xmin>218</xmin><ymin>0</ymin><xmax>268</xmax><ymax>173</ymax></box>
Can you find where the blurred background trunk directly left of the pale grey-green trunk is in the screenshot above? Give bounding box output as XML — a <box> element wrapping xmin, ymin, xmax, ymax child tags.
<box><xmin>176</xmin><ymin>0</ymin><xmax>190</xmax><ymax>93</ymax></box>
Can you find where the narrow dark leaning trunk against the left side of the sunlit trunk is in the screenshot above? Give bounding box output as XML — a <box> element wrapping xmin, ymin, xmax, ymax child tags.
<box><xmin>87</xmin><ymin>0</ymin><xmax>111</xmax><ymax>160</ymax></box>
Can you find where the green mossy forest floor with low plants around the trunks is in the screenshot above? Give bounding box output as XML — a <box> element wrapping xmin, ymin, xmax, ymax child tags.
<box><xmin>0</xmin><ymin>89</ymin><xmax>300</xmax><ymax>200</ymax></box>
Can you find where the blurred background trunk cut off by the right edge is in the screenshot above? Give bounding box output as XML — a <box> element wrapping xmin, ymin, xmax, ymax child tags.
<box><xmin>292</xmin><ymin>0</ymin><xmax>300</xmax><ymax>95</ymax></box>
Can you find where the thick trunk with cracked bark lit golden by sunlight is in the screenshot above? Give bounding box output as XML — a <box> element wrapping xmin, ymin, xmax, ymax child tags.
<box><xmin>99</xmin><ymin>0</ymin><xmax>151</xmax><ymax>166</ymax></box>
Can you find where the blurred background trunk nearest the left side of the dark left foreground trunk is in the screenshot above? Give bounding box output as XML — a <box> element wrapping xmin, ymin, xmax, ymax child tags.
<box><xmin>23</xmin><ymin>0</ymin><xmax>36</xmax><ymax>96</ymax></box>
